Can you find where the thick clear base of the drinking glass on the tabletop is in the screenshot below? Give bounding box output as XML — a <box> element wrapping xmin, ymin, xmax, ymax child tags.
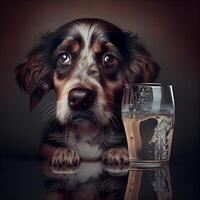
<box><xmin>129</xmin><ymin>160</ymin><xmax>169</xmax><ymax>168</ymax></box>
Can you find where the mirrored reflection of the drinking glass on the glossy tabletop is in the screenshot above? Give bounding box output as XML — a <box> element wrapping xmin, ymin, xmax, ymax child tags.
<box><xmin>124</xmin><ymin>166</ymin><xmax>172</xmax><ymax>200</ymax></box>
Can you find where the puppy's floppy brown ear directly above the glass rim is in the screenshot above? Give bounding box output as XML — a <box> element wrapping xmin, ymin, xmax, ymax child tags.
<box><xmin>126</xmin><ymin>32</ymin><xmax>160</xmax><ymax>82</ymax></box>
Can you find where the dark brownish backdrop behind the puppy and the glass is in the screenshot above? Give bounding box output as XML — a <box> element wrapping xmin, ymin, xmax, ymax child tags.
<box><xmin>0</xmin><ymin>0</ymin><xmax>200</xmax><ymax>199</ymax></box>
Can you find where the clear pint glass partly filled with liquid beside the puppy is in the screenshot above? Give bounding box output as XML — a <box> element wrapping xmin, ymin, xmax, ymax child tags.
<box><xmin>122</xmin><ymin>83</ymin><xmax>175</xmax><ymax>167</ymax></box>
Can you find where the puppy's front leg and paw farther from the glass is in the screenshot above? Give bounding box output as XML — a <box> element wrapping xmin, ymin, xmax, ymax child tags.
<box><xmin>41</xmin><ymin>144</ymin><xmax>80</xmax><ymax>167</ymax></box>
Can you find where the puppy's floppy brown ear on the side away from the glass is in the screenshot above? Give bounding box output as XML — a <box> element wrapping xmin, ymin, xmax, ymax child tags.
<box><xmin>15</xmin><ymin>33</ymin><xmax>53</xmax><ymax>110</ymax></box>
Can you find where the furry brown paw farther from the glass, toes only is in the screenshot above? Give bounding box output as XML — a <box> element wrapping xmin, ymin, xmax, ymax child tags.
<box><xmin>50</xmin><ymin>147</ymin><xmax>80</xmax><ymax>167</ymax></box>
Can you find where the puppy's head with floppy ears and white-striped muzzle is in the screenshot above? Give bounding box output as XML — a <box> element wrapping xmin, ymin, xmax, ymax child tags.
<box><xmin>16</xmin><ymin>19</ymin><xmax>159</xmax><ymax>126</ymax></box>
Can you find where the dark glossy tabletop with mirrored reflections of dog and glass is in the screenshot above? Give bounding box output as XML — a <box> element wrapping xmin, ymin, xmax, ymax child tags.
<box><xmin>0</xmin><ymin>159</ymin><xmax>198</xmax><ymax>200</ymax></box>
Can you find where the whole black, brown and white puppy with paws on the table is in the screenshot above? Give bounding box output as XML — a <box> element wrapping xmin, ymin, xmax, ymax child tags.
<box><xmin>16</xmin><ymin>19</ymin><xmax>159</xmax><ymax>166</ymax></box>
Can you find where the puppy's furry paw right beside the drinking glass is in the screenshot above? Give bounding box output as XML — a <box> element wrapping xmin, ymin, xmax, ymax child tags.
<box><xmin>102</xmin><ymin>147</ymin><xmax>129</xmax><ymax>165</ymax></box>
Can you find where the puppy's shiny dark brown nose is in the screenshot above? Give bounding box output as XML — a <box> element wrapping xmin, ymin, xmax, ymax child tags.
<box><xmin>68</xmin><ymin>88</ymin><xmax>96</xmax><ymax>110</ymax></box>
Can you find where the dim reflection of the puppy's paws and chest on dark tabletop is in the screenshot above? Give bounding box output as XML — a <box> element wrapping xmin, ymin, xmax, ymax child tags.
<box><xmin>43</xmin><ymin>162</ymin><xmax>128</xmax><ymax>200</ymax></box>
